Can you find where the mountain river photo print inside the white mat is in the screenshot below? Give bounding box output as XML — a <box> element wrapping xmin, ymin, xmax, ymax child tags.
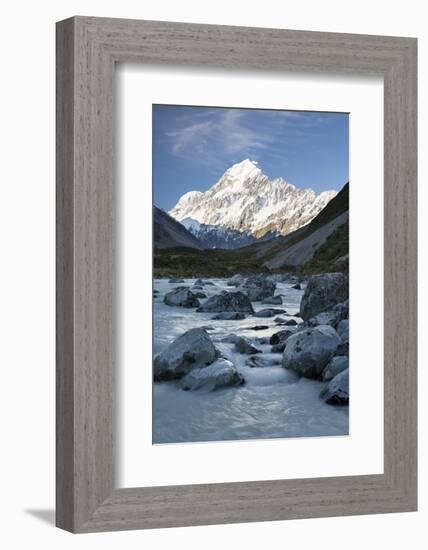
<box><xmin>153</xmin><ymin>104</ymin><xmax>350</xmax><ymax>444</ymax></box>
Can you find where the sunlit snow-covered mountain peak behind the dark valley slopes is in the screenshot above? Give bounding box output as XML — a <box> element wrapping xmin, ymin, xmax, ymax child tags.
<box><xmin>169</xmin><ymin>159</ymin><xmax>337</xmax><ymax>248</ymax></box>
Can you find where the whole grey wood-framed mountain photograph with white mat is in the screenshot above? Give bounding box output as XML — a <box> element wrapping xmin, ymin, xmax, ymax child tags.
<box><xmin>57</xmin><ymin>17</ymin><xmax>417</xmax><ymax>533</ymax></box>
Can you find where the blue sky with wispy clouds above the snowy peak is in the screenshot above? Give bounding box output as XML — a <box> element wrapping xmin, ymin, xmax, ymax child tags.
<box><xmin>153</xmin><ymin>105</ymin><xmax>349</xmax><ymax>210</ymax></box>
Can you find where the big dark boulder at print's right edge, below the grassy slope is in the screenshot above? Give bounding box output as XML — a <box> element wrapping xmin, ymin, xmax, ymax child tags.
<box><xmin>300</xmin><ymin>273</ymin><xmax>349</xmax><ymax>321</ymax></box>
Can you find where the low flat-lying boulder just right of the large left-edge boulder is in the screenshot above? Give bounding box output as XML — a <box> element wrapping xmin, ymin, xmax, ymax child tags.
<box><xmin>178</xmin><ymin>358</ymin><xmax>244</xmax><ymax>391</ymax></box>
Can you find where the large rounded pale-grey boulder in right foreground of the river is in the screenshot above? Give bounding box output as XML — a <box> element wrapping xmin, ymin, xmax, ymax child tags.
<box><xmin>282</xmin><ymin>325</ymin><xmax>341</xmax><ymax>378</ymax></box>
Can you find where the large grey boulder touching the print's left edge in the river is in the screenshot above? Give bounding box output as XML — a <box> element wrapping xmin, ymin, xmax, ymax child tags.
<box><xmin>154</xmin><ymin>328</ymin><xmax>218</xmax><ymax>382</ymax></box>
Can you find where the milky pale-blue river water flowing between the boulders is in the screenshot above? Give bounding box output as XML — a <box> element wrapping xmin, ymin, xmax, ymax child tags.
<box><xmin>153</xmin><ymin>279</ymin><xmax>348</xmax><ymax>443</ymax></box>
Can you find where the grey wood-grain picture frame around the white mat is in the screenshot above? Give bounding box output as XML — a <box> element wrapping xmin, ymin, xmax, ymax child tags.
<box><xmin>57</xmin><ymin>17</ymin><xmax>417</xmax><ymax>533</ymax></box>
